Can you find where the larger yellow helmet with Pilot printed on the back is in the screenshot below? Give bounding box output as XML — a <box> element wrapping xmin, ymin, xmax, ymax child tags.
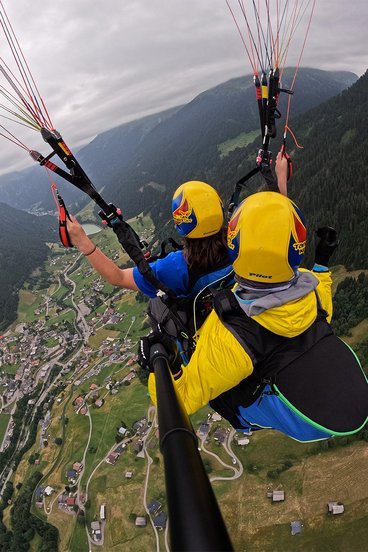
<box><xmin>227</xmin><ymin>192</ymin><xmax>307</xmax><ymax>283</ymax></box>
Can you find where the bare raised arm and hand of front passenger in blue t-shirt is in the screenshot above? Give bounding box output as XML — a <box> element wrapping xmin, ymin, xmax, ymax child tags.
<box><xmin>66</xmin><ymin>215</ymin><xmax>138</xmax><ymax>291</ymax></box>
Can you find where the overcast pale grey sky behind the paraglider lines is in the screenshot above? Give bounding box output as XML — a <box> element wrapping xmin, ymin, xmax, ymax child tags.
<box><xmin>0</xmin><ymin>0</ymin><xmax>368</xmax><ymax>174</ymax></box>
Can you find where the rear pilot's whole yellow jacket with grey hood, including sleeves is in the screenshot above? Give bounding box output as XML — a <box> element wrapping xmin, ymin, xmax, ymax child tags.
<box><xmin>148</xmin><ymin>269</ymin><xmax>332</xmax><ymax>414</ymax></box>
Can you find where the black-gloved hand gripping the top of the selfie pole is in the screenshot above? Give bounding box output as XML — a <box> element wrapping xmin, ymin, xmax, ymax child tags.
<box><xmin>138</xmin><ymin>333</ymin><xmax>182</xmax><ymax>379</ymax></box>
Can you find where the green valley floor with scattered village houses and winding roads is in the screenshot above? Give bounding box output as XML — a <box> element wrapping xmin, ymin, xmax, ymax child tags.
<box><xmin>0</xmin><ymin>220</ymin><xmax>368</xmax><ymax>552</ymax></box>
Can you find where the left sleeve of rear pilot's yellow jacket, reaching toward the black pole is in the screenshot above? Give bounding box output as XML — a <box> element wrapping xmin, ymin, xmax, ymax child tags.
<box><xmin>148</xmin><ymin>311</ymin><xmax>253</xmax><ymax>414</ymax></box>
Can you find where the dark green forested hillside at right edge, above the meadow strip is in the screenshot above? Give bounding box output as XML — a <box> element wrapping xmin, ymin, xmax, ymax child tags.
<box><xmin>290</xmin><ymin>72</ymin><xmax>368</xmax><ymax>269</ymax></box>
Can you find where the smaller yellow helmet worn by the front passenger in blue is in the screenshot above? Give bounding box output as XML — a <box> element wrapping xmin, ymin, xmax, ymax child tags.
<box><xmin>172</xmin><ymin>180</ymin><xmax>224</xmax><ymax>238</ymax></box>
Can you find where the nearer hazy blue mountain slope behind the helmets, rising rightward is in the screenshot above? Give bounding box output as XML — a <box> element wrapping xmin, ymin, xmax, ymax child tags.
<box><xmin>90</xmin><ymin>69</ymin><xmax>356</xmax><ymax>216</ymax></box>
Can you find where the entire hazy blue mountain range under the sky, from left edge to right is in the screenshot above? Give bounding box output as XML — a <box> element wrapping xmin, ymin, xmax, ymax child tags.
<box><xmin>0</xmin><ymin>69</ymin><xmax>357</xmax><ymax>216</ymax></box>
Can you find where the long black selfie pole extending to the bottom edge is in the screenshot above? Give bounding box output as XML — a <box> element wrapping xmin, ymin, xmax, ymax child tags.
<box><xmin>153</xmin><ymin>344</ymin><xmax>233</xmax><ymax>552</ymax></box>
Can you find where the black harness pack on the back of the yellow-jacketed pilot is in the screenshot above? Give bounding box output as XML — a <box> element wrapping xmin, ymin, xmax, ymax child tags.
<box><xmin>210</xmin><ymin>290</ymin><xmax>368</xmax><ymax>435</ymax></box>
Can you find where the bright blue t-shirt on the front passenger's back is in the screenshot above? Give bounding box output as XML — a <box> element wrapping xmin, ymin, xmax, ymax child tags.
<box><xmin>133</xmin><ymin>251</ymin><xmax>232</xmax><ymax>298</ymax></box>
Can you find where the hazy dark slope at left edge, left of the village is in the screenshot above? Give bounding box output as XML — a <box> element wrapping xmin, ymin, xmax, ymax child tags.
<box><xmin>0</xmin><ymin>203</ymin><xmax>59</xmax><ymax>330</ymax></box>
